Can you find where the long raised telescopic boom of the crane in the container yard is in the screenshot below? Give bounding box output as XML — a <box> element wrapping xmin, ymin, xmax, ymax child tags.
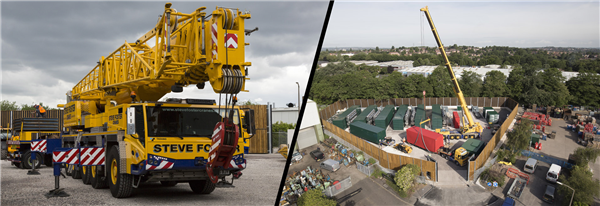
<box><xmin>421</xmin><ymin>7</ymin><xmax>482</xmax><ymax>132</ymax></box>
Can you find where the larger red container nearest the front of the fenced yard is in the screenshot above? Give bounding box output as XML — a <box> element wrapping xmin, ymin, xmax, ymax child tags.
<box><xmin>406</xmin><ymin>126</ymin><xmax>444</xmax><ymax>153</ymax></box>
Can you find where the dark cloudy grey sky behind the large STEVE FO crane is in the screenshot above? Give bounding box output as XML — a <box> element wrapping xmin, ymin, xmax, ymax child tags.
<box><xmin>0</xmin><ymin>1</ymin><xmax>328</xmax><ymax>107</ymax></box>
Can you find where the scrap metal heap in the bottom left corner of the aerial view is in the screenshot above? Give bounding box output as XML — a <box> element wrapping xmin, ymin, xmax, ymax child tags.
<box><xmin>280</xmin><ymin>166</ymin><xmax>336</xmax><ymax>205</ymax></box>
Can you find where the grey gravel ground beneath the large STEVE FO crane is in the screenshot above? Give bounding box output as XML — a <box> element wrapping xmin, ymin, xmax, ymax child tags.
<box><xmin>0</xmin><ymin>154</ymin><xmax>285</xmax><ymax>206</ymax></box>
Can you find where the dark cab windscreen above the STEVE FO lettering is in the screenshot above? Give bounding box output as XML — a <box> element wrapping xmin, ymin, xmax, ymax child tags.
<box><xmin>146</xmin><ymin>106</ymin><xmax>241</xmax><ymax>138</ymax></box>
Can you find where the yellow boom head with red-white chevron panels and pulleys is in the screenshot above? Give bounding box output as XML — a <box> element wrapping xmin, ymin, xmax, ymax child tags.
<box><xmin>205</xmin><ymin>8</ymin><xmax>251</xmax><ymax>94</ymax></box>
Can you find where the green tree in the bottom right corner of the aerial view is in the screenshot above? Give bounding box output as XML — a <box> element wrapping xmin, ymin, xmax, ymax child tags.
<box><xmin>558</xmin><ymin>165</ymin><xmax>600</xmax><ymax>205</ymax></box>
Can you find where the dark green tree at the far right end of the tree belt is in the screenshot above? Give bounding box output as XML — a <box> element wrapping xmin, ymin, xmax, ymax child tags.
<box><xmin>566</xmin><ymin>71</ymin><xmax>600</xmax><ymax>107</ymax></box>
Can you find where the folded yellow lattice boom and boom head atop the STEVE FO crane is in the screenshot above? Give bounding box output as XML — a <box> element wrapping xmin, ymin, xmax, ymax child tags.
<box><xmin>70</xmin><ymin>3</ymin><xmax>251</xmax><ymax>104</ymax></box>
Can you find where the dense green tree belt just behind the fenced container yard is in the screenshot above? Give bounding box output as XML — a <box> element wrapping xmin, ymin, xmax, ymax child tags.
<box><xmin>309</xmin><ymin>61</ymin><xmax>600</xmax><ymax>108</ymax></box>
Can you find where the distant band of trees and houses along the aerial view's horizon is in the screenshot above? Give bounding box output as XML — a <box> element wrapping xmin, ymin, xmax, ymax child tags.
<box><xmin>319</xmin><ymin>44</ymin><xmax>600</xmax><ymax>73</ymax></box>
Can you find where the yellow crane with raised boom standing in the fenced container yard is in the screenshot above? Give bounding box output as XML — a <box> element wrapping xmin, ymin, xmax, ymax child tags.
<box><xmin>421</xmin><ymin>7</ymin><xmax>483</xmax><ymax>137</ymax></box>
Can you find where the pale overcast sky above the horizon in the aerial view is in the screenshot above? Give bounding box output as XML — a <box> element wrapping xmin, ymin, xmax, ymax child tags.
<box><xmin>323</xmin><ymin>1</ymin><xmax>600</xmax><ymax>48</ymax></box>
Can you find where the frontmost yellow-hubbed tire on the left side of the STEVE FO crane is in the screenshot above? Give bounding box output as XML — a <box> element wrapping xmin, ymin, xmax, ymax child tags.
<box><xmin>106</xmin><ymin>146</ymin><xmax>133</xmax><ymax>198</ymax></box>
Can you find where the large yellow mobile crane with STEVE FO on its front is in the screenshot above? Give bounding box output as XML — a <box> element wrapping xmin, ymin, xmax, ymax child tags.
<box><xmin>59</xmin><ymin>3</ymin><xmax>258</xmax><ymax>197</ymax></box>
